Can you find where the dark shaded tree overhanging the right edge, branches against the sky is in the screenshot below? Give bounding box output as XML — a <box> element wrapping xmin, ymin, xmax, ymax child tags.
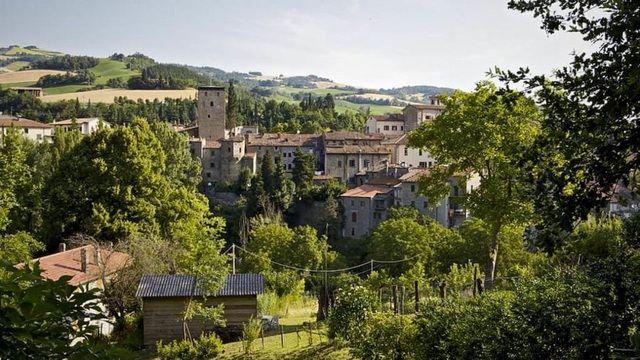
<box><xmin>498</xmin><ymin>0</ymin><xmax>640</xmax><ymax>252</ymax></box>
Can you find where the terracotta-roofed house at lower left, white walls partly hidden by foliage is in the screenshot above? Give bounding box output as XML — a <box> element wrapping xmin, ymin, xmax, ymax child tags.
<box><xmin>30</xmin><ymin>243</ymin><xmax>132</xmax><ymax>335</ymax></box>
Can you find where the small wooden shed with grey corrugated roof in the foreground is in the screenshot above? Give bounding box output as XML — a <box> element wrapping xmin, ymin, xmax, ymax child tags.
<box><xmin>136</xmin><ymin>274</ymin><xmax>264</xmax><ymax>346</ymax></box>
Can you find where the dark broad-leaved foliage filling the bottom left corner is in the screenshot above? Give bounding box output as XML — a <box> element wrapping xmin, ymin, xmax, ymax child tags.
<box><xmin>0</xmin><ymin>261</ymin><xmax>127</xmax><ymax>359</ymax></box>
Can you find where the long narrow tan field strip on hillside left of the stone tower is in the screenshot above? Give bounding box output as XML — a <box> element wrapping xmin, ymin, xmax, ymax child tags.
<box><xmin>42</xmin><ymin>89</ymin><xmax>196</xmax><ymax>104</ymax></box>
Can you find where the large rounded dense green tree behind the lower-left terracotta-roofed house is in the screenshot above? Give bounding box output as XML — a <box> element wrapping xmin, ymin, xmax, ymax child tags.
<box><xmin>45</xmin><ymin>119</ymin><xmax>170</xmax><ymax>245</ymax></box>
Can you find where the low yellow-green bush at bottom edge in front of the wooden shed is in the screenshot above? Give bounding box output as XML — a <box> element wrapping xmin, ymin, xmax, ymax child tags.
<box><xmin>157</xmin><ymin>333</ymin><xmax>222</xmax><ymax>360</ymax></box>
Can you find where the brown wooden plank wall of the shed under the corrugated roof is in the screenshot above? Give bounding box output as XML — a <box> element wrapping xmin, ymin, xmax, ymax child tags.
<box><xmin>142</xmin><ymin>295</ymin><xmax>258</xmax><ymax>346</ymax></box>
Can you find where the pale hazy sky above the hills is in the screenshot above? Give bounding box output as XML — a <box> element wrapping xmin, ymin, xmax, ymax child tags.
<box><xmin>0</xmin><ymin>0</ymin><xmax>588</xmax><ymax>91</ymax></box>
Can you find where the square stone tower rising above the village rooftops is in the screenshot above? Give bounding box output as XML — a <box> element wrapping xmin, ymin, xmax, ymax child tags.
<box><xmin>198</xmin><ymin>86</ymin><xmax>227</xmax><ymax>140</ymax></box>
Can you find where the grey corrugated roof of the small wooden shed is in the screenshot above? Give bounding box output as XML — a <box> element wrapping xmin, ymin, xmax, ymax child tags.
<box><xmin>136</xmin><ymin>274</ymin><xmax>264</xmax><ymax>298</ymax></box>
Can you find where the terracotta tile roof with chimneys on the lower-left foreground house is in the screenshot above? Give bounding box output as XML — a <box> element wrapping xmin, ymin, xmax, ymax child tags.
<box><xmin>31</xmin><ymin>245</ymin><xmax>132</xmax><ymax>286</ymax></box>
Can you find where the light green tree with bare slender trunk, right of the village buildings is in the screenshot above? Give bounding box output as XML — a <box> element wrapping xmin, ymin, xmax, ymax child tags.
<box><xmin>409</xmin><ymin>82</ymin><xmax>539</xmax><ymax>280</ymax></box>
